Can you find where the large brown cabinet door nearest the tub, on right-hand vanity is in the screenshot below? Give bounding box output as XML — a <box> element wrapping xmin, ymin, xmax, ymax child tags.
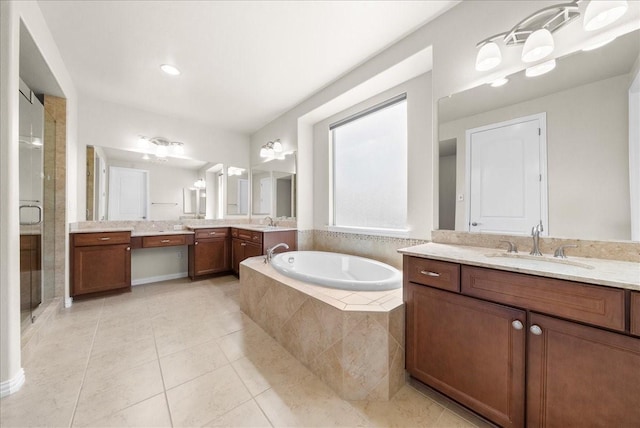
<box><xmin>406</xmin><ymin>282</ymin><xmax>526</xmax><ymax>427</ymax></box>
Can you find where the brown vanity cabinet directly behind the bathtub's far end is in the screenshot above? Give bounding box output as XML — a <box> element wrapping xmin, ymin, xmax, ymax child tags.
<box><xmin>231</xmin><ymin>227</ymin><xmax>298</xmax><ymax>275</ymax></box>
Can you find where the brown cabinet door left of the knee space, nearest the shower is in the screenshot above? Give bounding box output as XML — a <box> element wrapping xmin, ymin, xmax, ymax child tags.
<box><xmin>72</xmin><ymin>244</ymin><xmax>131</xmax><ymax>296</ymax></box>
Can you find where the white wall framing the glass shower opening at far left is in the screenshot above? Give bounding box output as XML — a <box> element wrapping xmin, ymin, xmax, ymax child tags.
<box><xmin>0</xmin><ymin>1</ymin><xmax>77</xmax><ymax>395</ymax></box>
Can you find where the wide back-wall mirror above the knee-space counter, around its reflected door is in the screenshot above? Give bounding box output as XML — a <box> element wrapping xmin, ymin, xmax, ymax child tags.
<box><xmin>87</xmin><ymin>146</ymin><xmax>213</xmax><ymax>220</ymax></box>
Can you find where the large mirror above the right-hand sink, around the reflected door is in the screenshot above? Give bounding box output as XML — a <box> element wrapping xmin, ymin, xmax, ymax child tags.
<box><xmin>438</xmin><ymin>31</ymin><xmax>640</xmax><ymax>240</ymax></box>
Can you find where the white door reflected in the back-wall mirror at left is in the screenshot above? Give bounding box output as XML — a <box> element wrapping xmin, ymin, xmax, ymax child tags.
<box><xmin>109</xmin><ymin>166</ymin><xmax>148</xmax><ymax>220</ymax></box>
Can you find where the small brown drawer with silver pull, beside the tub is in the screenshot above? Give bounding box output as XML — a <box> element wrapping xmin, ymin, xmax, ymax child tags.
<box><xmin>404</xmin><ymin>257</ymin><xmax>460</xmax><ymax>292</ymax></box>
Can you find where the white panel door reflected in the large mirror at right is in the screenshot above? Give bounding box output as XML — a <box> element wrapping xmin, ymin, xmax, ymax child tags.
<box><xmin>467</xmin><ymin>116</ymin><xmax>547</xmax><ymax>235</ymax></box>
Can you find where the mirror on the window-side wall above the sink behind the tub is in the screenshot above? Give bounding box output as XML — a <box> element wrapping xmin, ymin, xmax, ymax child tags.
<box><xmin>251</xmin><ymin>153</ymin><xmax>296</xmax><ymax>218</ymax></box>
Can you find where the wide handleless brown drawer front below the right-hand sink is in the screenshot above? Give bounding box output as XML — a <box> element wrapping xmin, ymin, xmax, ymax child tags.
<box><xmin>461</xmin><ymin>266</ymin><xmax>625</xmax><ymax>331</ymax></box>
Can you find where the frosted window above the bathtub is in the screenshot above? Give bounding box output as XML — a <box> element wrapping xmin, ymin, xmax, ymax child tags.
<box><xmin>330</xmin><ymin>95</ymin><xmax>407</xmax><ymax>230</ymax></box>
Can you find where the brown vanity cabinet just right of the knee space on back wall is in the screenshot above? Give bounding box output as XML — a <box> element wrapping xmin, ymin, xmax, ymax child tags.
<box><xmin>189</xmin><ymin>227</ymin><xmax>231</xmax><ymax>279</ymax></box>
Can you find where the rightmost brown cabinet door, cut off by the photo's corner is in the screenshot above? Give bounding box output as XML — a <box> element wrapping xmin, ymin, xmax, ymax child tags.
<box><xmin>527</xmin><ymin>314</ymin><xmax>640</xmax><ymax>427</ymax></box>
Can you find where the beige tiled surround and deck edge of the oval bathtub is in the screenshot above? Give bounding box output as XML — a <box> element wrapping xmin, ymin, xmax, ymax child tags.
<box><xmin>240</xmin><ymin>257</ymin><xmax>405</xmax><ymax>401</ymax></box>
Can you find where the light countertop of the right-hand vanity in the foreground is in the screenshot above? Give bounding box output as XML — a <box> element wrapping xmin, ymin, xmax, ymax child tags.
<box><xmin>398</xmin><ymin>243</ymin><xmax>640</xmax><ymax>291</ymax></box>
